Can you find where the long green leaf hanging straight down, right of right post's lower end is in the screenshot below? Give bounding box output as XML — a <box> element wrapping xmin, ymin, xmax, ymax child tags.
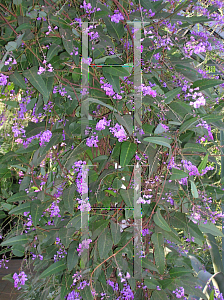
<box><xmin>151</xmin><ymin>233</ymin><xmax>165</xmax><ymax>274</ymax></box>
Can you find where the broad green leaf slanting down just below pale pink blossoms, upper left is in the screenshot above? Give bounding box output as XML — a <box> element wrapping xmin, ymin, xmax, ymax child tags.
<box><xmin>23</xmin><ymin>66</ymin><xmax>50</xmax><ymax>103</ymax></box>
